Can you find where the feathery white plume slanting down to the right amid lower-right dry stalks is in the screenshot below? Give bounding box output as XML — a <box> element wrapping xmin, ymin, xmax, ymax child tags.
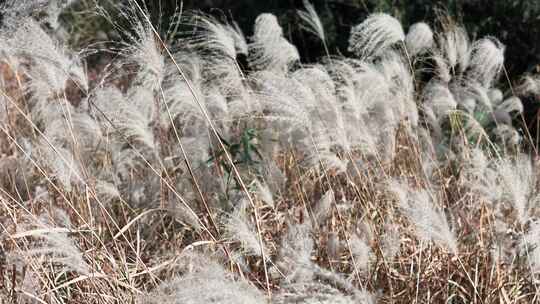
<box><xmin>390</xmin><ymin>181</ymin><xmax>458</xmax><ymax>254</ymax></box>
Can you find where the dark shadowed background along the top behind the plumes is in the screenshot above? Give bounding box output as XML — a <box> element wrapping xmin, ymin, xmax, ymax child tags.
<box><xmin>136</xmin><ymin>0</ymin><xmax>540</xmax><ymax>78</ymax></box>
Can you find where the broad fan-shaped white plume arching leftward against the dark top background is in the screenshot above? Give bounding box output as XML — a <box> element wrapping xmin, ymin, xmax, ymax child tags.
<box><xmin>348</xmin><ymin>13</ymin><xmax>405</xmax><ymax>60</ymax></box>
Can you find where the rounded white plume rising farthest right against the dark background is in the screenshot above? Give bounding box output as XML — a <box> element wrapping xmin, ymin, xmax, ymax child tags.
<box><xmin>467</xmin><ymin>37</ymin><xmax>505</xmax><ymax>88</ymax></box>
